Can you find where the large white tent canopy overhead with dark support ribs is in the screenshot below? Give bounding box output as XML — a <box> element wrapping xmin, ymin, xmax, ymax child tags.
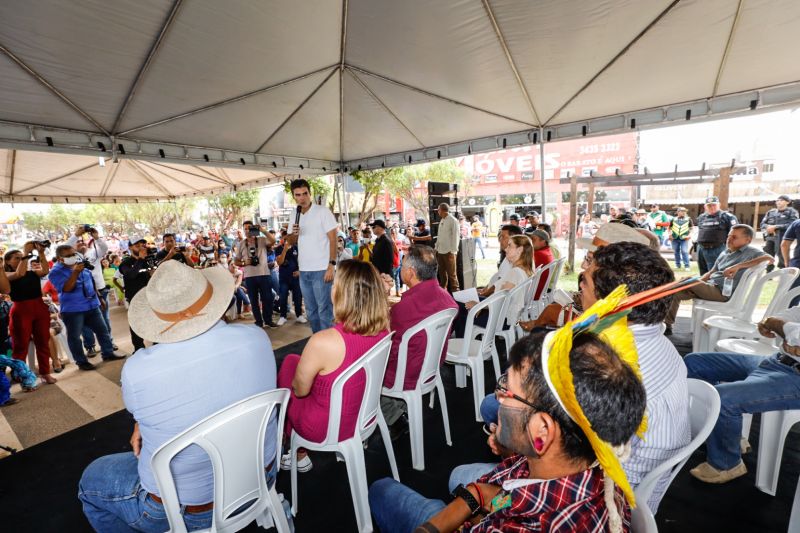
<box><xmin>0</xmin><ymin>0</ymin><xmax>800</xmax><ymax>199</ymax></box>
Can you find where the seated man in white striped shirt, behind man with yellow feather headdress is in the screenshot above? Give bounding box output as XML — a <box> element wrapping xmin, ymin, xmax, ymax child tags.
<box><xmin>476</xmin><ymin>242</ymin><xmax>691</xmax><ymax>513</ymax></box>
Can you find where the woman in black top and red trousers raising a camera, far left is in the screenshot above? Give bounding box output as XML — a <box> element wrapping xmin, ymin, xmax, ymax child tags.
<box><xmin>0</xmin><ymin>241</ymin><xmax>56</xmax><ymax>383</ymax></box>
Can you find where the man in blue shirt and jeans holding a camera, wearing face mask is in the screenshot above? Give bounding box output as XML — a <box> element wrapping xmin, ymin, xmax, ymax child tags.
<box><xmin>47</xmin><ymin>244</ymin><xmax>124</xmax><ymax>370</ymax></box>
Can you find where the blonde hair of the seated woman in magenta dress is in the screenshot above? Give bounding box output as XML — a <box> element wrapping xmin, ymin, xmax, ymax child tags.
<box><xmin>333</xmin><ymin>259</ymin><xmax>389</xmax><ymax>335</ymax></box>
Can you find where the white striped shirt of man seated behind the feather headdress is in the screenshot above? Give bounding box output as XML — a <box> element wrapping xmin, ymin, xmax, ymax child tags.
<box><xmin>622</xmin><ymin>324</ymin><xmax>691</xmax><ymax>514</ymax></box>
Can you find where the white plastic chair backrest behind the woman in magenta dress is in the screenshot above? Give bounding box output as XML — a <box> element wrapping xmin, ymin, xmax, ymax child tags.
<box><xmin>323</xmin><ymin>331</ymin><xmax>394</xmax><ymax>445</ymax></box>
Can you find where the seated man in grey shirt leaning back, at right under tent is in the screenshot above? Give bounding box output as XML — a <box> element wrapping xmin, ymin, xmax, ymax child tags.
<box><xmin>664</xmin><ymin>224</ymin><xmax>773</xmax><ymax>335</ymax></box>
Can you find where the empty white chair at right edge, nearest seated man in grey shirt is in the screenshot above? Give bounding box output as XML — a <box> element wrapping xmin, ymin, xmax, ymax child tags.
<box><xmin>692</xmin><ymin>268</ymin><xmax>800</xmax><ymax>352</ymax></box>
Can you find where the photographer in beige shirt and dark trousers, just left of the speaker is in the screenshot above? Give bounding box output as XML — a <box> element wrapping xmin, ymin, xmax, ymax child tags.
<box><xmin>235</xmin><ymin>220</ymin><xmax>277</xmax><ymax>328</ymax></box>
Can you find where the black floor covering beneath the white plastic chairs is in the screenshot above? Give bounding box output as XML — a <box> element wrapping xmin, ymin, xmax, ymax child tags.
<box><xmin>0</xmin><ymin>321</ymin><xmax>800</xmax><ymax>533</ymax></box>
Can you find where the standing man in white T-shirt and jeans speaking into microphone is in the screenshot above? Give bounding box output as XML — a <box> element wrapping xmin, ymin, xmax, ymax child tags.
<box><xmin>287</xmin><ymin>179</ymin><xmax>339</xmax><ymax>333</ymax></box>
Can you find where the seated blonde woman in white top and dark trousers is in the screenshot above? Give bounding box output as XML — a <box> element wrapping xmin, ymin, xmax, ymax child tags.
<box><xmin>453</xmin><ymin>235</ymin><xmax>533</xmax><ymax>338</ymax></box>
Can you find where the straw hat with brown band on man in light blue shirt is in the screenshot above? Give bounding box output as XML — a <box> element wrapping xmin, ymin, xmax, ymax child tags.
<box><xmin>128</xmin><ymin>261</ymin><xmax>233</xmax><ymax>343</ymax></box>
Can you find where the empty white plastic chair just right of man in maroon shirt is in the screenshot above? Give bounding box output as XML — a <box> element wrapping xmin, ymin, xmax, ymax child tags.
<box><xmin>445</xmin><ymin>290</ymin><xmax>508</xmax><ymax>422</ymax></box>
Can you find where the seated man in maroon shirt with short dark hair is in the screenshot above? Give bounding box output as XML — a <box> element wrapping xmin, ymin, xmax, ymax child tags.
<box><xmin>381</xmin><ymin>244</ymin><xmax>458</xmax><ymax>426</ymax></box>
